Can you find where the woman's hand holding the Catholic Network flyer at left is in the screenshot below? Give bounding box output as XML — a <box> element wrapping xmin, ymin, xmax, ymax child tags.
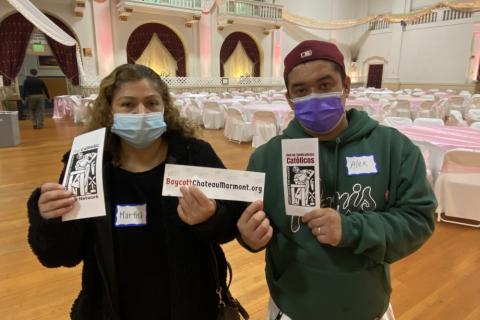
<box><xmin>38</xmin><ymin>182</ymin><xmax>77</xmax><ymax>219</ymax></box>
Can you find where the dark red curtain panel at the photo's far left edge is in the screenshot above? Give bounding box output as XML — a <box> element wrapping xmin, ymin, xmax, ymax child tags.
<box><xmin>0</xmin><ymin>13</ymin><xmax>33</xmax><ymax>86</ymax></box>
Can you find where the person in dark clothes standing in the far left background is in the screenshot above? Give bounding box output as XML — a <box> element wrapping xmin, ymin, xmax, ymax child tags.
<box><xmin>22</xmin><ymin>69</ymin><xmax>50</xmax><ymax>129</ymax></box>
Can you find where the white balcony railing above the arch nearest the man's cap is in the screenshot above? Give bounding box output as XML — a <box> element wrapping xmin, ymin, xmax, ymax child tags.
<box><xmin>218</xmin><ymin>0</ymin><xmax>283</xmax><ymax>21</ymax></box>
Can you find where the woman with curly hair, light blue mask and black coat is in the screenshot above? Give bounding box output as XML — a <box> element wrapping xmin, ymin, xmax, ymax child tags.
<box><xmin>28</xmin><ymin>65</ymin><xmax>241</xmax><ymax>320</ymax></box>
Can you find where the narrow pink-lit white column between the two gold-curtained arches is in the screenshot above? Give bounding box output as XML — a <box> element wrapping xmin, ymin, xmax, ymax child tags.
<box><xmin>198</xmin><ymin>13</ymin><xmax>212</xmax><ymax>78</ymax></box>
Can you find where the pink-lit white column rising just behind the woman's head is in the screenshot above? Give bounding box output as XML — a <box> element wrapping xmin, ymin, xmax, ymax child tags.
<box><xmin>92</xmin><ymin>1</ymin><xmax>115</xmax><ymax>78</ymax></box>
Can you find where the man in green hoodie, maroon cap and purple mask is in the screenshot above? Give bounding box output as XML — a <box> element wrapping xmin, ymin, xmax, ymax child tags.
<box><xmin>237</xmin><ymin>41</ymin><xmax>436</xmax><ymax>320</ymax></box>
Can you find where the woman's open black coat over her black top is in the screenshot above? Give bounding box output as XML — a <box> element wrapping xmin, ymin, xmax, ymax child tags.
<box><xmin>28</xmin><ymin>134</ymin><xmax>244</xmax><ymax>320</ymax></box>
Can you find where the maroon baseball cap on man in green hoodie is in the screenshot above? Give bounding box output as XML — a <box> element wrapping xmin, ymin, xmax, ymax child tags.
<box><xmin>283</xmin><ymin>40</ymin><xmax>345</xmax><ymax>83</ymax></box>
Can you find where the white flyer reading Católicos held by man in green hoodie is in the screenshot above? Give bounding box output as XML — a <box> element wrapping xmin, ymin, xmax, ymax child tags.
<box><xmin>282</xmin><ymin>138</ymin><xmax>320</xmax><ymax>216</ymax></box>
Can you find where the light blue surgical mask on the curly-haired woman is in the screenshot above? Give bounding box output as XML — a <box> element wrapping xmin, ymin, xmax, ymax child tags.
<box><xmin>111</xmin><ymin>112</ymin><xmax>167</xmax><ymax>149</ymax></box>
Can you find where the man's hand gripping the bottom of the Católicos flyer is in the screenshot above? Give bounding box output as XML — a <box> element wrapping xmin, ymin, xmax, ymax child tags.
<box><xmin>302</xmin><ymin>208</ymin><xmax>342</xmax><ymax>247</ymax></box>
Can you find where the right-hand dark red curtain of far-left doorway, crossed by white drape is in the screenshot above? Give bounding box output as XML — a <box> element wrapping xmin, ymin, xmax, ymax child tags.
<box><xmin>45</xmin><ymin>15</ymin><xmax>80</xmax><ymax>86</ymax></box>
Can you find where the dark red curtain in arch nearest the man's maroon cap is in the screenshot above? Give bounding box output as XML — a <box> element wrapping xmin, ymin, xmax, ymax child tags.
<box><xmin>220</xmin><ymin>32</ymin><xmax>260</xmax><ymax>77</ymax></box>
